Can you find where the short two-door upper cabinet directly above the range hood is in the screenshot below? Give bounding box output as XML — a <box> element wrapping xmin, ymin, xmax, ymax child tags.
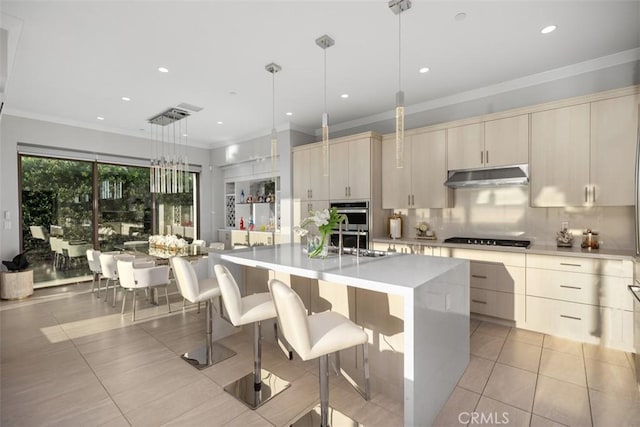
<box><xmin>447</xmin><ymin>114</ymin><xmax>529</xmax><ymax>170</ymax></box>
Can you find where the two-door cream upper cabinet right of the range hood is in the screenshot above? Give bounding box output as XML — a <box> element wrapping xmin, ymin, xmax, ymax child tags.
<box><xmin>530</xmin><ymin>94</ymin><xmax>638</xmax><ymax>207</ymax></box>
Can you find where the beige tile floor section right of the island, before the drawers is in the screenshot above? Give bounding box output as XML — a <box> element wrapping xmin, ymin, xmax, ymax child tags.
<box><xmin>435</xmin><ymin>320</ymin><xmax>640</xmax><ymax>427</ymax></box>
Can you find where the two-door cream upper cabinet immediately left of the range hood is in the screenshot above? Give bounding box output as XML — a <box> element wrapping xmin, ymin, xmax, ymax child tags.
<box><xmin>382</xmin><ymin>130</ymin><xmax>449</xmax><ymax>209</ymax></box>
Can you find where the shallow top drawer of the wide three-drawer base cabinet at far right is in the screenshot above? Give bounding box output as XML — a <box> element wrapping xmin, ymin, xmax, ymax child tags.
<box><xmin>527</xmin><ymin>254</ymin><xmax>633</xmax><ymax>278</ymax></box>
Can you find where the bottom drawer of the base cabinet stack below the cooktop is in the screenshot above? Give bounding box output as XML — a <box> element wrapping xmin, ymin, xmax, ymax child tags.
<box><xmin>469</xmin><ymin>288</ymin><xmax>525</xmax><ymax>322</ymax></box>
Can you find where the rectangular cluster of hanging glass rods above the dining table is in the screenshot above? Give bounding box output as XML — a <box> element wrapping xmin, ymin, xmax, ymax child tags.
<box><xmin>149</xmin><ymin>108</ymin><xmax>191</xmax><ymax>193</ymax></box>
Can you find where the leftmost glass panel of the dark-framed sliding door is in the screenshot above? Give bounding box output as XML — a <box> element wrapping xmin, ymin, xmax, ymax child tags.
<box><xmin>20</xmin><ymin>156</ymin><xmax>93</xmax><ymax>284</ymax></box>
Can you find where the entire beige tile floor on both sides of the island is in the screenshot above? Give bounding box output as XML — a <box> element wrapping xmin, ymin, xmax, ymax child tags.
<box><xmin>0</xmin><ymin>283</ymin><xmax>640</xmax><ymax>427</ymax></box>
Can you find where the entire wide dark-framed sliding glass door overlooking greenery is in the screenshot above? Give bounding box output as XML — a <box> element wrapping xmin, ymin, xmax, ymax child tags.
<box><xmin>20</xmin><ymin>155</ymin><xmax>199</xmax><ymax>286</ymax></box>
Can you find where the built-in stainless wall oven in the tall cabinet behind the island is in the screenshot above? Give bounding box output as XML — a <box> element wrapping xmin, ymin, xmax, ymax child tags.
<box><xmin>330</xmin><ymin>200</ymin><xmax>369</xmax><ymax>249</ymax></box>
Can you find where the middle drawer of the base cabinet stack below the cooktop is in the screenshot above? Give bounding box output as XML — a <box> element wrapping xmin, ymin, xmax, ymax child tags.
<box><xmin>469</xmin><ymin>261</ymin><xmax>525</xmax><ymax>294</ymax></box>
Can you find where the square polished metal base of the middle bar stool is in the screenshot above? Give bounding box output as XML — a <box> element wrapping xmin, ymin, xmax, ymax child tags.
<box><xmin>224</xmin><ymin>369</ymin><xmax>291</xmax><ymax>409</ymax></box>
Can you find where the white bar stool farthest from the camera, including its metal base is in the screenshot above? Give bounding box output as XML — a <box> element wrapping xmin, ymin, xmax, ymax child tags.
<box><xmin>170</xmin><ymin>256</ymin><xmax>236</xmax><ymax>369</ymax></box>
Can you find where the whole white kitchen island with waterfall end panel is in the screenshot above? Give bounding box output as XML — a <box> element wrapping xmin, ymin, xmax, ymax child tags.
<box><xmin>220</xmin><ymin>244</ymin><xmax>469</xmax><ymax>426</ymax></box>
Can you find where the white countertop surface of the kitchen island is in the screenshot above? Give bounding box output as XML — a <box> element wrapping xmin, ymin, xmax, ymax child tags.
<box><xmin>220</xmin><ymin>244</ymin><xmax>466</xmax><ymax>295</ymax></box>
